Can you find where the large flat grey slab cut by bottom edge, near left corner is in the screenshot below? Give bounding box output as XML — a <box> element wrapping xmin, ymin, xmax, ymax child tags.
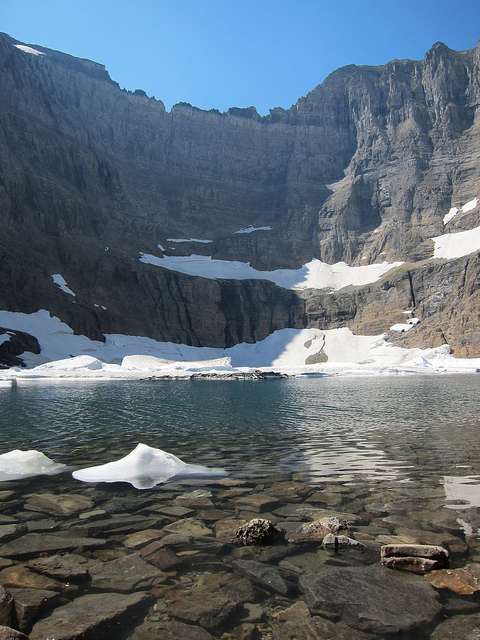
<box><xmin>29</xmin><ymin>593</ymin><xmax>152</xmax><ymax>640</ymax></box>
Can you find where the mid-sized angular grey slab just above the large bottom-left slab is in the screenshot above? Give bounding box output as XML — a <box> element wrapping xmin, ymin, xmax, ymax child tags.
<box><xmin>89</xmin><ymin>553</ymin><xmax>167</xmax><ymax>593</ymax></box>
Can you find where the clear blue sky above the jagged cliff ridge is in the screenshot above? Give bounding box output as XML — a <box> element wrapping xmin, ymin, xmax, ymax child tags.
<box><xmin>0</xmin><ymin>0</ymin><xmax>480</xmax><ymax>115</ymax></box>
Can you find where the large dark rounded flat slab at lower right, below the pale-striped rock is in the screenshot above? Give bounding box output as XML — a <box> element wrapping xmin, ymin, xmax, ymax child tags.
<box><xmin>299</xmin><ymin>565</ymin><xmax>441</xmax><ymax>634</ymax></box>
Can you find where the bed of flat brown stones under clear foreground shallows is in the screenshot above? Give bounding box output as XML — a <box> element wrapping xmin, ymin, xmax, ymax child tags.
<box><xmin>0</xmin><ymin>474</ymin><xmax>480</xmax><ymax>640</ymax></box>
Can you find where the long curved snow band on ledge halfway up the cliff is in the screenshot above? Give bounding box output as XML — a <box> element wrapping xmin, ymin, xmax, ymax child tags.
<box><xmin>139</xmin><ymin>252</ymin><xmax>403</xmax><ymax>291</ymax></box>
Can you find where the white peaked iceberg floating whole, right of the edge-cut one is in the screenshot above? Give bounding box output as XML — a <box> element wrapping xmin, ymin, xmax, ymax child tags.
<box><xmin>72</xmin><ymin>444</ymin><xmax>227</xmax><ymax>489</ymax></box>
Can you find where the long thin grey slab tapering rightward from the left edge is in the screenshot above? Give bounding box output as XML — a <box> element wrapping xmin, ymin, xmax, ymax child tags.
<box><xmin>0</xmin><ymin>533</ymin><xmax>107</xmax><ymax>558</ymax></box>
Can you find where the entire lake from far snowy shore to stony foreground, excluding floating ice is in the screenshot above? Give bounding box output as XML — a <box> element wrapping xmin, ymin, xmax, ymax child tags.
<box><xmin>0</xmin><ymin>376</ymin><xmax>480</xmax><ymax>640</ymax></box>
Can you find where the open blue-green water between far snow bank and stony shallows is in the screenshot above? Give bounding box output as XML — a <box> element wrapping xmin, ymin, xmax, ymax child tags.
<box><xmin>0</xmin><ymin>375</ymin><xmax>480</xmax><ymax>481</ymax></box>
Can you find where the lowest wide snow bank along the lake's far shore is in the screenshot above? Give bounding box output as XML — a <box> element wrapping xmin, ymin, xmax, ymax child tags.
<box><xmin>0</xmin><ymin>311</ymin><xmax>480</xmax><ymax>383</ymax></box>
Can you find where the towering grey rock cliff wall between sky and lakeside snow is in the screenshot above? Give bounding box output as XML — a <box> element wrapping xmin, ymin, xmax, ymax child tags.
<box><xmin>0</xmin><ymin>35</ymin><xmax>480</xmax><ymax>362</ymax></box>
